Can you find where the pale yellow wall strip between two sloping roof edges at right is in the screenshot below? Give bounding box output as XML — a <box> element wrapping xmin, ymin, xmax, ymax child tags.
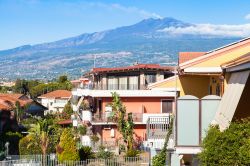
<box><xmin>192</xmin><ymin>43</ymin><xmax>250</xmax><ymax>67</ymax></box>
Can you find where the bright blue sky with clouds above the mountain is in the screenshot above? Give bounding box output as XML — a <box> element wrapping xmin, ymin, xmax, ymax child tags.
<box><xmin>0</xmin><ymin>0</ymin><xmax>250</xmax><ymax>50</ymax></box>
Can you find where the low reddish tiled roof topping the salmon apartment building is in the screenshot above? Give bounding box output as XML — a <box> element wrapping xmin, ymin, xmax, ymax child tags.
<box><xmin>86</xmin><ymin>64</ymin><xmax>174</xmax><ymax>73</ymax></box>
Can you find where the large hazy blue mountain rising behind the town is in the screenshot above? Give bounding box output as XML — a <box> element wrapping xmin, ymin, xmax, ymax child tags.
<box><xmin>0</xmin><ymin>17</ymin><xmax>238</xmax><ymax>79</ymax></box>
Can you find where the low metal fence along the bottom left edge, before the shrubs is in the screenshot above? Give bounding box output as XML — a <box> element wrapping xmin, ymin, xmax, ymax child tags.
<box><xmin>0</xmin><ymin>155</ymin><xmax>150</xmax><ymax>166</ymax></box>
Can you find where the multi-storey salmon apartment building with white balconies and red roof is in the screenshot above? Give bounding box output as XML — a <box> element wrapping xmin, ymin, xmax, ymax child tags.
<box><xmin>72</xmin><ymin>64</ymin><xmax>176</xmax><ymax>152</ymax></box>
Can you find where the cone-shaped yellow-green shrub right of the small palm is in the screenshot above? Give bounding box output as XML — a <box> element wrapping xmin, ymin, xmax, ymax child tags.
<box><xmin>57</xmin><ymin>128</ymin><xmax>80</xmax><ymax>162</ymax></box>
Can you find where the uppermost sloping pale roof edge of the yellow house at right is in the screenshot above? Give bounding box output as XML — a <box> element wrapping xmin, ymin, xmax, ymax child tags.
<box><xmin>180</xmin><ymin>38</ymin><xmax>250</xmax><ymax>69</ymax></box>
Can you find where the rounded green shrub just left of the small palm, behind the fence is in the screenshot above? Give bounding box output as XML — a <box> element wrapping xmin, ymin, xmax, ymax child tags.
<box><xmin>19</xmin><ymin>135</ymin><xmax>42</xmax><ymax>155</ymax></box>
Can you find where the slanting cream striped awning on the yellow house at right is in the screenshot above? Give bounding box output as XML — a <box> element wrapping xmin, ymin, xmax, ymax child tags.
<box><xmin>213</xmin><ymin>70</ymin><xmax>250</xmax><ymax>130</ymax></box>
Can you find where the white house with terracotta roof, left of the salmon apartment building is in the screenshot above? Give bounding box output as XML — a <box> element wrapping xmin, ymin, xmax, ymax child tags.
<box><xmin>38</xmin><ymin>90</ymin><xmax>71</xmax><ymax>113</ymax></box>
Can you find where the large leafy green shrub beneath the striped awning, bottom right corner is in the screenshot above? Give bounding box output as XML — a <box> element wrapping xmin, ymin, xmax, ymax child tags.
<box><xmin>198</xmin><ymin>119</ymin><xmax>250</xmax><ymax>166</ymax></box>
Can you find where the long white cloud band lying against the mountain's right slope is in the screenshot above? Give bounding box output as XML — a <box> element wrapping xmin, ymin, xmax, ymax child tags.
<box><xmin>159</xmin><ymin>24</ymin><xmax>250</xmax><ymax>37</ymax></box>
